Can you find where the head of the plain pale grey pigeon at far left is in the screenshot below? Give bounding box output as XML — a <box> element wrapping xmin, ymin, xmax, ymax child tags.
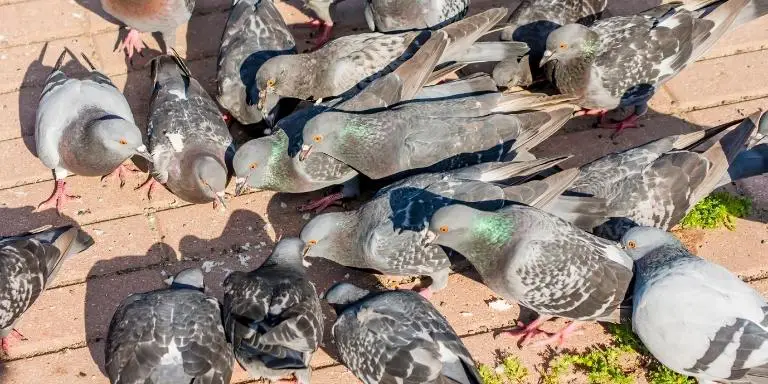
<box><xmin>88</xmin><ymin>115</ymin><xmax>152</xmax><ymax>162</ymax></box>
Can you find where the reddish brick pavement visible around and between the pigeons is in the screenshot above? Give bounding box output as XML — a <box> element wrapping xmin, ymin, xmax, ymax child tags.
<box><xmin>0</xmin><ymin>0</ymin><xmax>768</xmax><ymax>384</ymax></box>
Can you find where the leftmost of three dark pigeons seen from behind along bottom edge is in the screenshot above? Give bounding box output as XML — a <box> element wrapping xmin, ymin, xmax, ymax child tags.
<box><xmin>104</xmin><ymin>268</ymin><xmax>232</xmax><ymax>384</ymax></box>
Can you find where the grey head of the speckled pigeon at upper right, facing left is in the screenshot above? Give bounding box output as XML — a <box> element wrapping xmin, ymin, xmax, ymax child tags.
<box><xmin>539</xmin><ymin>24</ymin><xmax>599</xmax><ymax>67</ymax></box>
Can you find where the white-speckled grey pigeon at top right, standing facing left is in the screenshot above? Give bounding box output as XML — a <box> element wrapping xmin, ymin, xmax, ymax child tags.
<box><xmin>540</xmin><ymin>0</ymin><xmax>749</xmax><ymax>134</ymax></box>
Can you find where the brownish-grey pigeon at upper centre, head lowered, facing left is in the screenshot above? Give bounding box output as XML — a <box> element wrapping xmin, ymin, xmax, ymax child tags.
<box><xmin>256</xmin><ymin>8</ymin><xmax>528</xmax><ymax>112</ymax></box>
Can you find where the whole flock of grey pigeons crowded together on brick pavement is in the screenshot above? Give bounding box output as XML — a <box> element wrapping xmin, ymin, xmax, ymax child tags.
<box><xmin>0</xmin><ymin>0</ymin><xmax>768</xmax><ymax>384</ymax></box>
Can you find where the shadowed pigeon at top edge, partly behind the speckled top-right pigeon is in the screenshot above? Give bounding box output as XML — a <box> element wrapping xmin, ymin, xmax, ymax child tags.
<box><xmin>494</xmin><ymin>0</ymin><xmax>608</xmax><ymax>80</ymax></box>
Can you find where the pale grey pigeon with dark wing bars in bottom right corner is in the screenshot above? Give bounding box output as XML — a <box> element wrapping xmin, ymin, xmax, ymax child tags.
<box><xmin>621</xmin><ymin>227</ymin><xmax>768</xmax><ymax>384</ymax></box>
